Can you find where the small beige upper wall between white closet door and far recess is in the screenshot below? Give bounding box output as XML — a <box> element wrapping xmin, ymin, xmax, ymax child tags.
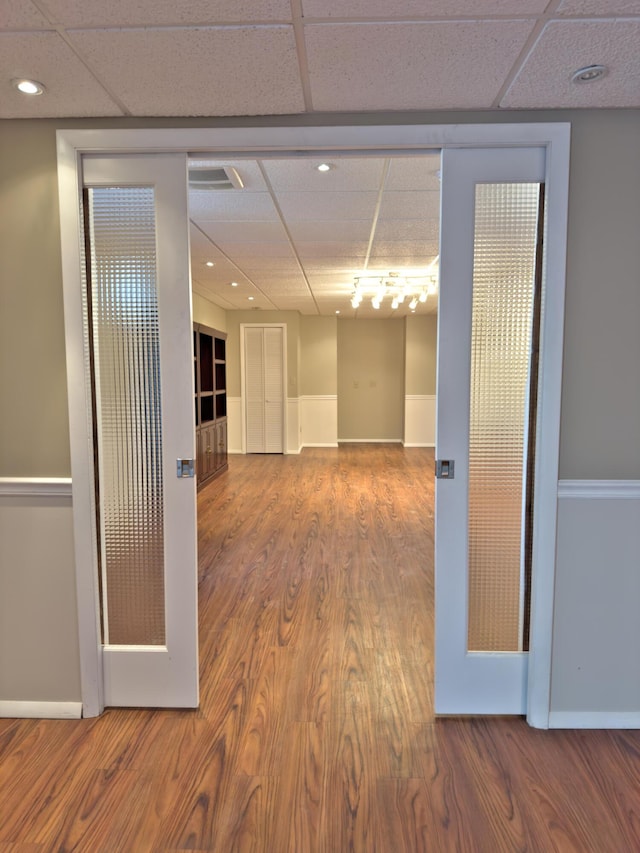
<box><xmin>300</xmin><ymin>317</ymin><xmax>338</xmax><ymax>395</ymax></box>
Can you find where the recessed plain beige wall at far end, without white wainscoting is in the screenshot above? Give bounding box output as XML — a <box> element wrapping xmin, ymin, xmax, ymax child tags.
<box><xmin>338</xmin><ymin>319</ymin><xmax>404</xmax><ymax>441</ymax></box>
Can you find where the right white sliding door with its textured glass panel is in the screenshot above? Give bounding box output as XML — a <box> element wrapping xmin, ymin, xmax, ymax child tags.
<box><xmin>435</xmin><ymin>148</ymin><xmax>545</xmax><ymax>714</ymax></box>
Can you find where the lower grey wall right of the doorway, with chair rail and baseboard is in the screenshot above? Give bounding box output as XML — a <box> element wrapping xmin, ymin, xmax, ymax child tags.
<box><xmin>549</xmin><ymin>481</ymin><xmax>640</xmax><ymax>728</ymax></box>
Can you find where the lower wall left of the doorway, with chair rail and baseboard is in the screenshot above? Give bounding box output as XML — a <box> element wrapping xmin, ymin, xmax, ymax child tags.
<box><xmin>0</xmin><ymin>478</ymin><xmax>81</xmax><ymax>704</ymax></box>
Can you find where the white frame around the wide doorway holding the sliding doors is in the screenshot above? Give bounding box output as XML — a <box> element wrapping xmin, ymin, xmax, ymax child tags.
<box><xmin>56</xmin><ymin>123</ymin><xmax>570</xmax><ymax>728</ymax></box>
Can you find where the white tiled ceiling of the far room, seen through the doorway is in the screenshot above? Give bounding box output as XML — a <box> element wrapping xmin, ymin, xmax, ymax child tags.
<box><xmin>189</xmin><ymin>151</ymin><xmax>440</xmax><ymax>318</ymax></box>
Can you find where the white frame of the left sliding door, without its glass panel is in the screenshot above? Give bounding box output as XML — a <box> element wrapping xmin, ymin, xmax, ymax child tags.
<box><xmin>83</xmin><ymin>154</ymin><xmax>198</xmax><ymax>707</ymax></box>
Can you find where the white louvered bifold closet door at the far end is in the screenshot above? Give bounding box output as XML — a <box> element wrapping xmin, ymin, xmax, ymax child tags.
<box><xmin>242</xmin><ymin>325</ymin><xmax>285</xmax><ymax>453</ymax></box>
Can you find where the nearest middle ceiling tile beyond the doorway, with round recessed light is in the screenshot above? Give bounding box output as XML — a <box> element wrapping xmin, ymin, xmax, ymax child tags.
<box><xmin>263</xmin><ymin>155</ymin><xmax>384</xmax><ymax>193</ymax></box>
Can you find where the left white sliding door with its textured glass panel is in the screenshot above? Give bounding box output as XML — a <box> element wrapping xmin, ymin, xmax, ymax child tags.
<box><xmin>83</xmin><ymin>154</ymin><xmax>198</xmax><ymax>707</ymax></box>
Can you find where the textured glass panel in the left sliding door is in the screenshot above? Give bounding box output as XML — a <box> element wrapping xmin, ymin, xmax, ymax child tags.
<box><xmin>88</xmin><ymin>187</ymin><xmax>165</xmax><ymax>645</ymax></box>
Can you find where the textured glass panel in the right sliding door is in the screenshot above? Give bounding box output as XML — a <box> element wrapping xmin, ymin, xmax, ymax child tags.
<box><xmin>468</xmin><ymin>184</ymin><xmax>540</xmax><ymax>651</ymax></box>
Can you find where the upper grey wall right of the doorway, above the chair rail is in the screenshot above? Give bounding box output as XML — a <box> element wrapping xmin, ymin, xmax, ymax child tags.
<box><xmin>560</xmin><ymin>110</ymin><xmax>640</xmax><ymax>479</ymax></box>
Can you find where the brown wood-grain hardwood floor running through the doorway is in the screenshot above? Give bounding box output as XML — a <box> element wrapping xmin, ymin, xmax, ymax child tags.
<box><xmin>0</xmin><ymin>445</ymin><xmax>640</xmax><ymax>853</ymax></box>
